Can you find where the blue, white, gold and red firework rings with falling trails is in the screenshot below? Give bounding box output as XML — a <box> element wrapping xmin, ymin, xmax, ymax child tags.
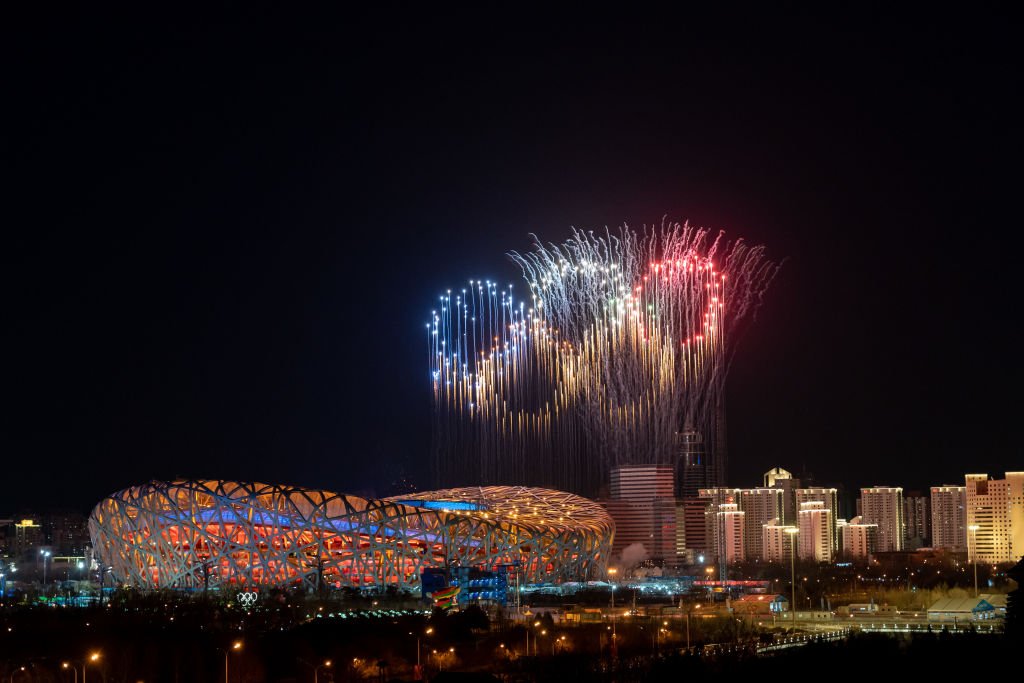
<box><xmin>427</xmin><ymin>223</ymin><xmax>778</xmax><ymax>495</ymax></box>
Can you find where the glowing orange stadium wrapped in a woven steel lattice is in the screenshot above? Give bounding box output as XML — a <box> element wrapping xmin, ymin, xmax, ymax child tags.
<box><xmin>89</xmin><ymin>480</ymin><xmax>614</xmax><ymax>590</ymax></box>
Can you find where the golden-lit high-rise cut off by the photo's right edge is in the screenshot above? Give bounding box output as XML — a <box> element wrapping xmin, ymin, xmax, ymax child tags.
<box><xmin>965</xmin><ymin>472</ymin><xmax>1024</xmax><ymax>564</ymax></box>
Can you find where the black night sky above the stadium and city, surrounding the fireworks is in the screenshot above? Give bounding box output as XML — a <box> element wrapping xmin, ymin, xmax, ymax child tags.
<box><xmin>0</xmin><ymin>14</ymin><xmax>1024</xmax><ymax>514</ymax></box>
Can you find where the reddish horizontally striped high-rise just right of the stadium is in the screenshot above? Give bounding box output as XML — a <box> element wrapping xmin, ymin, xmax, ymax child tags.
<box><xmin>601</xmin><ymin>465</ymin><xmax>677</xmax><ymax>560</ymax></box>
